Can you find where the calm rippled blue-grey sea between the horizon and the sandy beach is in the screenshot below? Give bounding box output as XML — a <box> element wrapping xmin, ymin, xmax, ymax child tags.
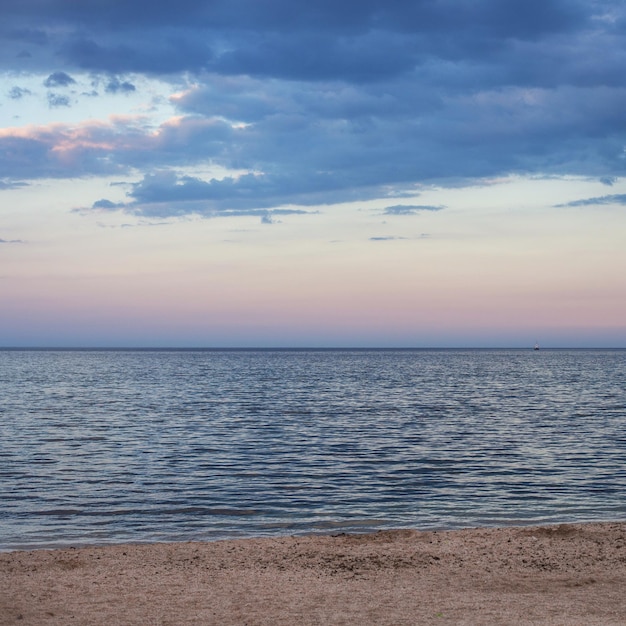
<box><xmin>0</xmin><ymin>350</ymin><xmax>626</xmax><ymax>549</ymax></box>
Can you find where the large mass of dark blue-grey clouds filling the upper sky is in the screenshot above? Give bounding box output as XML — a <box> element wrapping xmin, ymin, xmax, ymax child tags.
<box><xmin>0</xmin><ymin>0</ymin><xmax>626</xmax><ymax>216</ymax></box>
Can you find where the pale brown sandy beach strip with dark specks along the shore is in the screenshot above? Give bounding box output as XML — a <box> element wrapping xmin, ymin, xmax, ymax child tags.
<box><xmin>0</xmin><ymin>523</ymin><xmax>626</xmax><ymax>626</ymax></box>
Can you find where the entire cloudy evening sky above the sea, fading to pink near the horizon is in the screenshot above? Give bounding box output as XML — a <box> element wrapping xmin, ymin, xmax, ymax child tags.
<box><xmin>0</xmin><ymin>0</ymin><xmax>626</xmax><ymax>348</ymax></box>
